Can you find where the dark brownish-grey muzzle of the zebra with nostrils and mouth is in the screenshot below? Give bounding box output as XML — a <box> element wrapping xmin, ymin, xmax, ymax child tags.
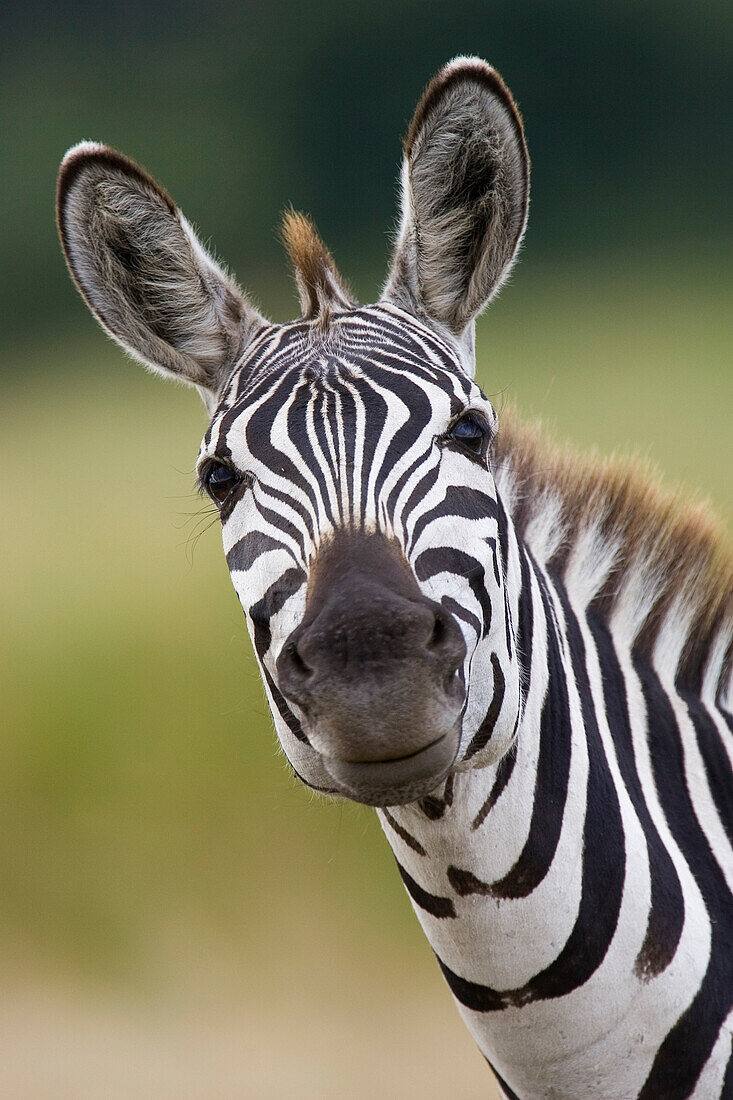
<box><xmin>277</xmin><ymin>534</ymin><xmax>466</xmax><ymax>805</ymax></box>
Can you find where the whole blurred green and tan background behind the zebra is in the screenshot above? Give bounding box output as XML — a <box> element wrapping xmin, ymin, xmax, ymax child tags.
<box><xmin>0</xmin><ymin>0</ymin><xmax>733</xmax><ymax>1100</ymax></box>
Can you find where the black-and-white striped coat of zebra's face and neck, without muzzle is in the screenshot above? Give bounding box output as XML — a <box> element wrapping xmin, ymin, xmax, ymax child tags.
<box><xmin>201</xmin><ymin>304</ymin><xmax>733</xmax><ymax>1100</ymax></box>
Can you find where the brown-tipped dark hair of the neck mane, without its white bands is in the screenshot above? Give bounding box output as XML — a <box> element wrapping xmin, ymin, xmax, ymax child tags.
<box><xmin>494</xmin><ymin>409</ymin><xmax>733</xmax><ymax>684</ymax></box>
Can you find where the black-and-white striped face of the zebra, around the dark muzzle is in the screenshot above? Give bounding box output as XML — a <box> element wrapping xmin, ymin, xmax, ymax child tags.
<box><xmin>199</xmin><ymin>305</ymin><xmax>519</xmax><ymax>790</ymax></box>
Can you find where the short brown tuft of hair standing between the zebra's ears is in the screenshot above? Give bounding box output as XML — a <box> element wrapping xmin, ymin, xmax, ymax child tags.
<box><xmin>281</xmin><ymin>210</ymin><xmax>354</xmax><ymax>320</ymax></box>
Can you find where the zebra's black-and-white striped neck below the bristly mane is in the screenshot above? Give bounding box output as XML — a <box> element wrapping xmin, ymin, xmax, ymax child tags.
<box><xmin>380</xmin><ymin>556</ymin><xmax>733</xmax><ymax>1098</ymax></box>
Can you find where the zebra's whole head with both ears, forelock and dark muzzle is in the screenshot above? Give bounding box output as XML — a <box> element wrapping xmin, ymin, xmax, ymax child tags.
<box><xmin>58</xmin><ymin>58</ymin><xmax>528</xmax><ymax>805</ymax></box>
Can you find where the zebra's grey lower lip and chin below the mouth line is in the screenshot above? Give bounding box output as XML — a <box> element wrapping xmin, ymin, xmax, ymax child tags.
<box><xmin>322</xmin><ymin>723</ymin><xmax>460</xmax><ymax>806</ymax></box>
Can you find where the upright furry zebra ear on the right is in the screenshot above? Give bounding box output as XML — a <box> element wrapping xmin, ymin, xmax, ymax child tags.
<box><xmin>384</xmin><ymin>57</ymin><xmax>529</xmax><ymax>338</ymax></box>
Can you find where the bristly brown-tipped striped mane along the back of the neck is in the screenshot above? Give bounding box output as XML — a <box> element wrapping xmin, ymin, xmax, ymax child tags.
<box><xmin>494</xmin><ymin>409</ymin><xmax>733</xmax><ymax>697</ymax></box>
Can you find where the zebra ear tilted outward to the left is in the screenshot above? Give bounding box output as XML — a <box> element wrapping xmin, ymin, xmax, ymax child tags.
<box><xmin>56</xmin><ymin>142</ymin><xmax>265</xmax><ymax>406</ymax></box>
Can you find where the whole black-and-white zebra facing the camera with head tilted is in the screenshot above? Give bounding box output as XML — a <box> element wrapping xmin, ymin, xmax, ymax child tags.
<box><xmin>57</xmin><ymin>57</ymin><xmax>733</xmax><ymax>1100</ymax></box>
